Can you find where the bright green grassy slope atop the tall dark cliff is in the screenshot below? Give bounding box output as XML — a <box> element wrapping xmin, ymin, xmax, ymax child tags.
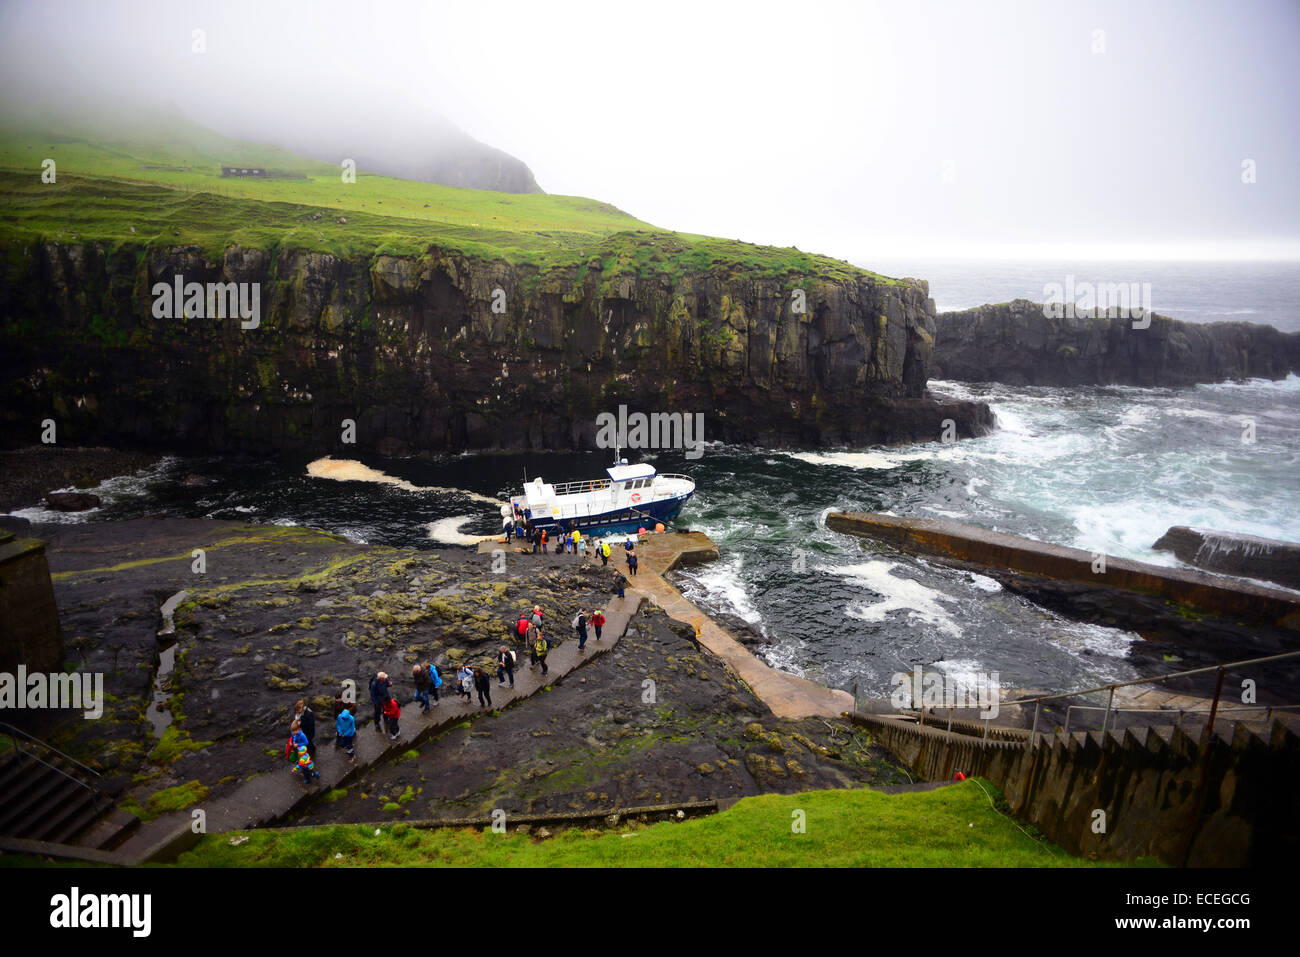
<box><xmin>0</xmin><ymin>125</ymin><xmax>892</xmax><ymax>282</ymax></box>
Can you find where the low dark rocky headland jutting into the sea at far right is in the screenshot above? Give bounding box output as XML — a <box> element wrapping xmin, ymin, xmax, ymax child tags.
<box><xmin>931</xmin><ymin>299</ymin><xmax>1300</xmax><ymax>386</ymax></box>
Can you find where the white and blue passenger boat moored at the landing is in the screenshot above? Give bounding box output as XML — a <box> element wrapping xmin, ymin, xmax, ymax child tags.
<box><xmin>501</xmin><ymin>459</ymin><xmax>696</xmax><ymax>534</ymax></box>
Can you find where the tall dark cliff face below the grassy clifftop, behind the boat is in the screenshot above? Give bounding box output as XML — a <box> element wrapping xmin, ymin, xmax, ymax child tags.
<box><xmin>0</xmin><ymin>243</ymin><xmax>992</xmax><ymax>454</ymax></box>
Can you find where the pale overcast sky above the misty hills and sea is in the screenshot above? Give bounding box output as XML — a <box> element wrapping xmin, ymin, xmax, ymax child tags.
<box><xmin>0</xmin><ymin>0</ymin><xmax>1300</xmax><ymax>264</ymax></box>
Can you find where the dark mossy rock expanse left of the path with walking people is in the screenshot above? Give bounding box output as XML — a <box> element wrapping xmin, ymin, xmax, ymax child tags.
<box><xmin>22</xmin><ymin>519</ymin><xmax>626</xmax><ymax>807</ymax></box>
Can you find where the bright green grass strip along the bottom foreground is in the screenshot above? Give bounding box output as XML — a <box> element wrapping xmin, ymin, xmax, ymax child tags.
<box><xmin>167</xmin><ymin>781</ymin><xmax>1152</xmax><ymax>867</ymax></box>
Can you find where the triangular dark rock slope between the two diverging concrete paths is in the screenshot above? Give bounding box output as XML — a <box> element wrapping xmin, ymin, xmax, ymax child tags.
<box><xmin>295</xmin><ymin>606</ymin><xmax>909</xmax><ymax>823</ymax></box>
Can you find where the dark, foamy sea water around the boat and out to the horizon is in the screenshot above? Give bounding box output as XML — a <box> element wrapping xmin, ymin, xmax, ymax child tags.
<box><xmin>18</xmin><ymin>264</ymin><xmax>1300</xmax><ymax>697</ymax></box>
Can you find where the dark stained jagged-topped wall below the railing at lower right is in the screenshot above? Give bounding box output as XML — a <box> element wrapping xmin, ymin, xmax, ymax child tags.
<box><xmin>854</xmin><ymin>714</ymin><xmax>1300</xmax><ymax>867</ymax></box>
